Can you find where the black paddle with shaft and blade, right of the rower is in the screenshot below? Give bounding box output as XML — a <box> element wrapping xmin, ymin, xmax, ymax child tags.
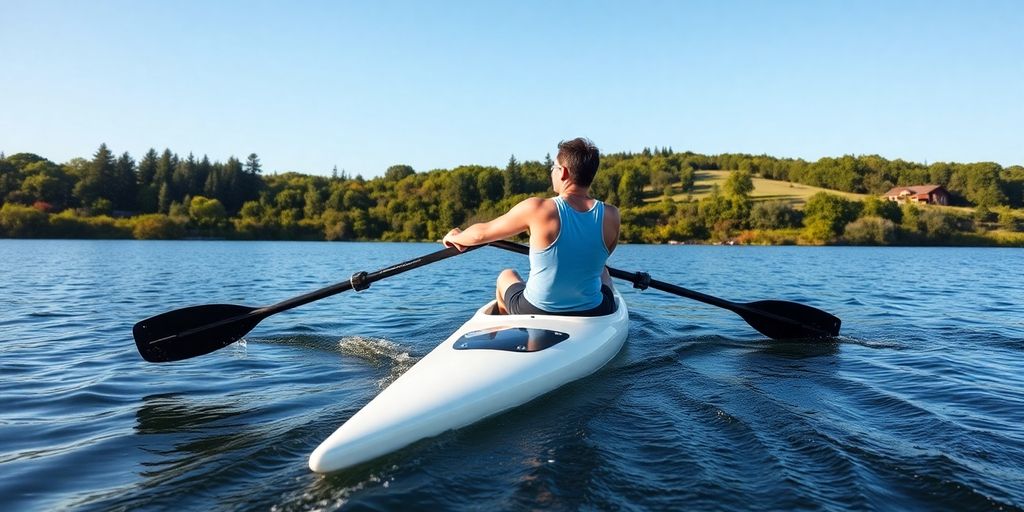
<box><xmin>490</xmin><ymin>240</ymin><xmax>842</xmax><ymax>340</ymax></box>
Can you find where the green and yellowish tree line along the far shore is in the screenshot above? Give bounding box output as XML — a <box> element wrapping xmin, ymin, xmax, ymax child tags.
<box><xmin>0</xmin><ymin>144</ymin><xmax>1024</xmax><ymax>244</ymax></box>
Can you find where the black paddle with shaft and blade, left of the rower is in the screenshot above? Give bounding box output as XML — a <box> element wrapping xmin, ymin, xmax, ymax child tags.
<box><xmin>132</xmin><ymin>247</ymin><xmax>476</xmax><ymax>362</ymax></box>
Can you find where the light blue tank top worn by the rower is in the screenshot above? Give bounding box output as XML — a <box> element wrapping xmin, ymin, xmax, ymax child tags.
<box><xmin>523</xmin><ymin>197</ymin><xmax>608</xmax><ymax>312</ymax></box>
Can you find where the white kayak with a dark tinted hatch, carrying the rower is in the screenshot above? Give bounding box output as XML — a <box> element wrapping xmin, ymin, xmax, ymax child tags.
<box><xmin>309</xmin><ymin>292</ymin><xmax>629</xmax><ymax>473</ymax></box>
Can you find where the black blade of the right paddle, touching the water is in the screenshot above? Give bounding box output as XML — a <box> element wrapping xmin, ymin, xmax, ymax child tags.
<box><xmin>734</xmin><ymin>300</ymin><xmax>842</xmax><ymax>340</ymax></box>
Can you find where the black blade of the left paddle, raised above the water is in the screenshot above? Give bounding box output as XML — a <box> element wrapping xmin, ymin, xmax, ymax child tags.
<box><xmin>132</xmin><ymin>304</ymin><xmax>264</xmax><ymax>362</ymax></box>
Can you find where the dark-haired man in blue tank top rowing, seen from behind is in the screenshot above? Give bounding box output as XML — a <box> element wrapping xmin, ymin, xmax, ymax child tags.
<box><xmin>441</xmin><ymin>137</ymin><xmax>620</xmax><ymax>316</ymax></box>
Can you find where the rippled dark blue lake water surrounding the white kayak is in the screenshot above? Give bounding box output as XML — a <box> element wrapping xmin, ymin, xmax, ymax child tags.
<box><xmin>0</xmin><ymin>240</ymin><xmax>1024</xmax><ymax>510</ymax></box>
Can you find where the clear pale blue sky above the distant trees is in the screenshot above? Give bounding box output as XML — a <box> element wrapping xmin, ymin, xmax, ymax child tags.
<box><xmin>0</xmin><ymin>0</ymin><xmax>1024</xmax><ymax>177</ymax></box>
